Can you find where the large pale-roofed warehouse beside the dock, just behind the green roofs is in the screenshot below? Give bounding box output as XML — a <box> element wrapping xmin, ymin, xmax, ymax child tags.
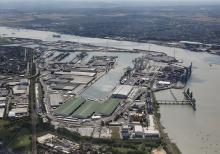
<box><xmin>112</xmin><ymin>85</ymin><xmax>132</xmax><ymax>99</ymax></box>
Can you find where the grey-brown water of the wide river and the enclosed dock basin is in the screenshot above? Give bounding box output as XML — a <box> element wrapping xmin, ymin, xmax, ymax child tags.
<box><xmin>0</xmin><ymin>27</ymin><xmax>220</xmax><ymax>154</ymax></box>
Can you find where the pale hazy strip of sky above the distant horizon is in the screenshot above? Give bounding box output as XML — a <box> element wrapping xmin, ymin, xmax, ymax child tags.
<box><xmin>0</xmin><ymin>0</ymin><xmax>220</xmax><ymax>9</ymax></box>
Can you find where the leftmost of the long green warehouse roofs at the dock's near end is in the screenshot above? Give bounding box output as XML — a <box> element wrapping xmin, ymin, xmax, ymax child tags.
<box><xmin>54</xmin><ymin>97</ymin><xmax>86</xmax><ymax>116</ymax></box>
